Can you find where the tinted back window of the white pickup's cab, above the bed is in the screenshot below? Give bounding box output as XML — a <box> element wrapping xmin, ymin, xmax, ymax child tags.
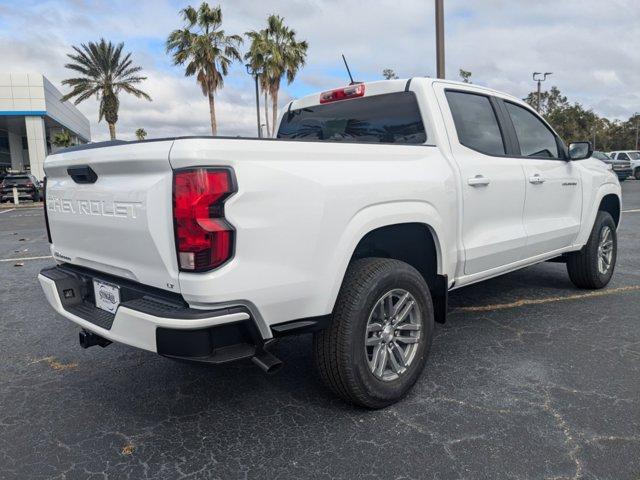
<box><xmin>278</xmin><ymin>92</ymin><xmax>427</xmax><ymax>144</ymax></box>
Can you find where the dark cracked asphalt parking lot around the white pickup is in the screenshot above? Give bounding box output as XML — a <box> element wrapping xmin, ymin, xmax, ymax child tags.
<box><xmin>0</xmin><ymin>180</ymin><xmax>640</xmax><ymax>480</ymax></box>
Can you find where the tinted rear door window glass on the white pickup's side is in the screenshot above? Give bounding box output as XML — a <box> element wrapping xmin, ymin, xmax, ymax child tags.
<box><xmin>446</xmin><ymin>91</ymin><xmax>505</xmax><ymax>155</ymax></box>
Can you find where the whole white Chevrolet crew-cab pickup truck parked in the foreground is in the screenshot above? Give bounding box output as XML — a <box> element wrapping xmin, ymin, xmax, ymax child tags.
<box><xmin>39</xmin><ymin>78</ymin><xmax>621</xmax><ymax>408</ymax></box>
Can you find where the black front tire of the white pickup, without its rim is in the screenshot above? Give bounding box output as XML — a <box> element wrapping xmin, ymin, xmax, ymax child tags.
<box><xmin>567</xmin><ymin>211</ymin><xmax>618</xmax><ymax>289</ymax></box>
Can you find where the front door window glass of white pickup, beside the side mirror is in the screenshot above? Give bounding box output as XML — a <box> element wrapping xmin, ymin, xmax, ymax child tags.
<box><xmin>505</xmin><ymin>102</ymin><xmax>559</xmax><ymax>158</ymax></box>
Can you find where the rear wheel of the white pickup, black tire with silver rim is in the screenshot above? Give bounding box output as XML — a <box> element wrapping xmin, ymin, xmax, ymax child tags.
<box><xmin>314</xmin><ymin>258</ymin><xmax>434</xmax><ymax>408</ymax></box>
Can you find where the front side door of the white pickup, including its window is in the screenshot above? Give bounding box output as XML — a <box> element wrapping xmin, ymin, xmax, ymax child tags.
<box><xmin>503</xmin><ymin>100</ymin><xmax>582</xmax><ymax>257</ymax></box>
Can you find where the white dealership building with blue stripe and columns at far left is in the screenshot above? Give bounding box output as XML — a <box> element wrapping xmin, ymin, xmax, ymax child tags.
<box><xmin>0</xmin><ymin>73</ymin><xmax>91</xmax><ymax>180</ymax></box>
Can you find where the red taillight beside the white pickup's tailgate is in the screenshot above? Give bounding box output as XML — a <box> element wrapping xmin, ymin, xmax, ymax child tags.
<box><xmin>173</xmin><ymin>168</ymin><xmax>236</xmax><ymax>272</ymax></box>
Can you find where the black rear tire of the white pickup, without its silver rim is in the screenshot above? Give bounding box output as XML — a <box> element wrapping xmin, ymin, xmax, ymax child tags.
<box><xmin>313</xmin><ymin>258</ymin><xmax>434</xmax><ymax>409</ymax></box>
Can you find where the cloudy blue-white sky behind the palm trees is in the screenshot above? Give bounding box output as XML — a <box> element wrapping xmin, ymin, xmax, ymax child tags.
<box><xmin>0</xmin><ymin>0</ymin><xmax>640</xmax><ymax>140</ymax></box>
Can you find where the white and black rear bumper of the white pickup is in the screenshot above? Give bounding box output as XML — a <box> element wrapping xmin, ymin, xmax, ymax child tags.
<box><xmin>38</xmin><ymin>266</ymin><xmax>265</xmax><ymax>363</ymax></box>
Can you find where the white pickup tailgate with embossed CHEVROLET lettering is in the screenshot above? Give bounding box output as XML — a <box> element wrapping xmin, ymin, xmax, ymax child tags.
<box><xmin>44</xmin><ymin>141</ymin><xmax>179</xmax><ymax>292</ymax></box>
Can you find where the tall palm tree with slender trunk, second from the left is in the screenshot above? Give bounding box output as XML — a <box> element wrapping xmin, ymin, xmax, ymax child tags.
<box><xmin>166</xmin><ymin>2</ymin><xmax>242</xmax><ymax>136</ymax></box>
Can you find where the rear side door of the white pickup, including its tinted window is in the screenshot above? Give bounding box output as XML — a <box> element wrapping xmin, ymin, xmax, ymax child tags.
<box><xmin>434</xmin><ymin>84</ymin><xmax>526</xmax><ymax>275</ymax></box>
